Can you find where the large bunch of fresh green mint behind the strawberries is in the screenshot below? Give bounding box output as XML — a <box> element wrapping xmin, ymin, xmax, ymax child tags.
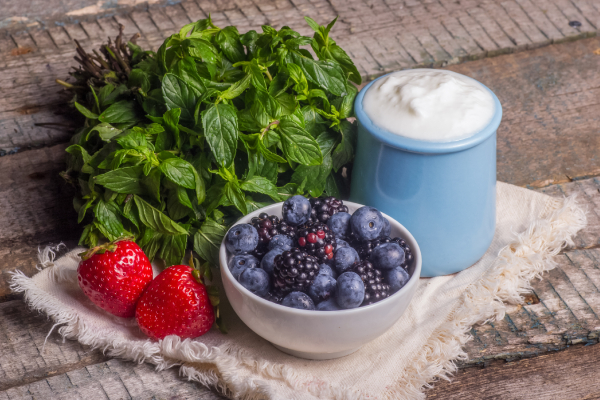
<box><xmin>59</xmin><ymin>16</ymin><xmax>361</xmax><ymax>265</ymax></box>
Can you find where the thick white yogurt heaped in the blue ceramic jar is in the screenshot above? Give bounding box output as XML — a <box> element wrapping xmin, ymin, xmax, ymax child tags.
<box><xmin>363</xmin><ymin>69</ymin><xmax>495</xmax><ymax>142</ymax></box>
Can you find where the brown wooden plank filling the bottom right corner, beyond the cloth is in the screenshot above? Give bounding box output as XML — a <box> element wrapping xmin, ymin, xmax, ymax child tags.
<box><xmin>426</xmin><ymin>345</ymin><xmax>600</xmax><ymax>400</ymax></box>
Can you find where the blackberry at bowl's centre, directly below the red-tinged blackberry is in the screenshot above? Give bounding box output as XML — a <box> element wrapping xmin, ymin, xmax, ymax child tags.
<box><xmin>273</xmin><ymin>248</ymin><xmax>319</xmax><ymax>297</ymax></box>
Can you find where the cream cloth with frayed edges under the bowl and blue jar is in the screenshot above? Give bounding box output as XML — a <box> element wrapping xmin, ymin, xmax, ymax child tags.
<box><xmin>12</xmin><ymin>182</ymin><xmax>586</xmax><ymax>400</ymax></box>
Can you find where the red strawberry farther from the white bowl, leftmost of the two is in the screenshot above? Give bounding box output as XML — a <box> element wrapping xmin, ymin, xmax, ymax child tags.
<box><xmin>77</xmin><ymin>240</ymin><xmax>152</xmax><ymax>318</ymax></box>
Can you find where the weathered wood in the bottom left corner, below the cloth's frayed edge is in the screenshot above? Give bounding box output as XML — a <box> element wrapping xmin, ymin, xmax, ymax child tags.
<box><xmin>0</xmin><ymin>300</ymin><xmax>221</xmax><ymax>400</ymax></box>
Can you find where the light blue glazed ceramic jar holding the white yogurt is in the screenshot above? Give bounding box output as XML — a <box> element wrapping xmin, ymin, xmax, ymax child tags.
<box><xmin>350</xmin><ymin>70</ymin><xmax>502</xmax><ymax>277</ymax></box>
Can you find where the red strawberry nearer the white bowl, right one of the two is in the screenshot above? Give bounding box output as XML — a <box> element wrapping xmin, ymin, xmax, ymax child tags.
<box><xmin>135</xmin><ymin>265</ymin><xmax>215</xmax><ymax>339</ymax></box>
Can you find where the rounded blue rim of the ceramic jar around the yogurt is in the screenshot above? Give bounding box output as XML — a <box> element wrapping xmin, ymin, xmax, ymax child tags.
<box><xmin>354</xmin><ymin>68</ymin><xmax>502</xmax><ymax>154</ymax></box>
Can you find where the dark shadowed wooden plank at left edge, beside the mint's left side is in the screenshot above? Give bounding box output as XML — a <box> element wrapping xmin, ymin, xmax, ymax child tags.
<box><xmin>0</xmin><ymin>145</ymin><xmax>81</xmax><ymax>299</ymax></box>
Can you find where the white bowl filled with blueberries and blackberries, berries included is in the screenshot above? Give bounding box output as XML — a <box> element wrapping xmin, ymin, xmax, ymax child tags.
<box><xmin>219</xmin><ymin>196</ymin><xmax>421</xmax><ymax>360</ymax></box>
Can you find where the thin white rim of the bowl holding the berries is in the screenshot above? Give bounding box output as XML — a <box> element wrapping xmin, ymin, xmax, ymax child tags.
<box><xmin>219</xmin><ymin>200</ymin><xmax>422</xmax><ymax>316</ymax></box>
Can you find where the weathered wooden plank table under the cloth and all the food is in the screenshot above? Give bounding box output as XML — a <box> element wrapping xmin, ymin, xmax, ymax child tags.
<box><xmin>0</xmin><ymin>0</ymin><xmax>600</xmax><ymax>400</ymax></box>
